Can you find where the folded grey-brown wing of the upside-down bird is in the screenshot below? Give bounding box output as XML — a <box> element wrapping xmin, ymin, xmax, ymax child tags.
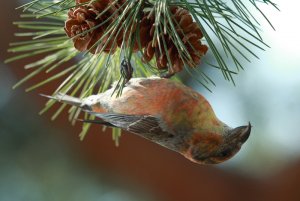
<box><xmin>87</xmin><ymin>111</ymin><xmax>174</xmax><ymax>137</ymax></box>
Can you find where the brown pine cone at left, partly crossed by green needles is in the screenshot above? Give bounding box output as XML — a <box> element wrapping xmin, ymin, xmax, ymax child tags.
<box><xmin>65</xmin><ymin>0</ymin><xmax>124</xmax><ymax>54</ymax></box>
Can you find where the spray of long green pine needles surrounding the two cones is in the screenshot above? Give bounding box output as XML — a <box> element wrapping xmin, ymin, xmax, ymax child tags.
<box><xmin>5</xmin><ymin>0</ymin><xmax>278</xmax><ymax>145</ymax></box>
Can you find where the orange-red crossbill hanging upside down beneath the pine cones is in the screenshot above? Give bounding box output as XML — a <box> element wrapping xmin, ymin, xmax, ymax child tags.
<box><xmin>41</xmin><ymin>78</ymin><xmax>251</xmax><ymax>164</ymax></box>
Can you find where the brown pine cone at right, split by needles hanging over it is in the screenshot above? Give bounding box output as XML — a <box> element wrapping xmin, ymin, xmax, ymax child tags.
<box><xmin>141</xmin><ymin>6</ymin><xmax>208</xmax><ymax>74</ymax></box>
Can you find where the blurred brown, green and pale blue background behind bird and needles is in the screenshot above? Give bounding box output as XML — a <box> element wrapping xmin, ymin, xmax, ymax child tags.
<box><xmin>0</xmin><ymin>0</ymin><xmax>300</xmax><ymax>201</ymax></box>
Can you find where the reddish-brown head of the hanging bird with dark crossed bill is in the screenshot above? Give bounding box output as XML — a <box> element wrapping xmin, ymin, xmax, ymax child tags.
<box><xmin>184</xmin><ymin>123</ymin><xmax>251</xmax><ymax>164</ymax></box>
